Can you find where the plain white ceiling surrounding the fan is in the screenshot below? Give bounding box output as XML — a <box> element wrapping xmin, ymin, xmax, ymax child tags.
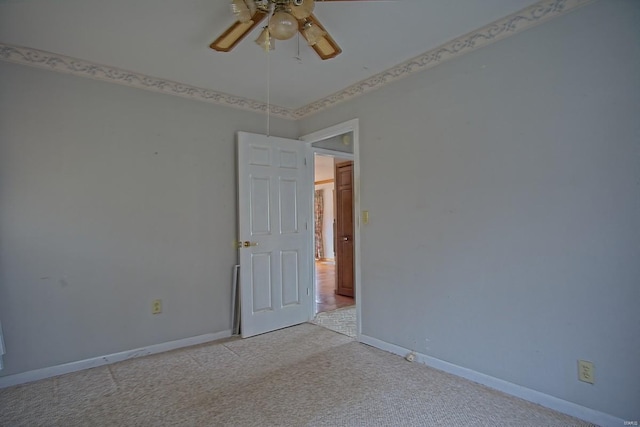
<box><xmin>0</xmin><ymin>0</ymin><xmax>536</xmax><ymax>109</ymax></box>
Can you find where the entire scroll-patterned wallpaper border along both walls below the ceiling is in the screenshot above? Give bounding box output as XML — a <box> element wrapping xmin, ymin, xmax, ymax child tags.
<box><xmin>0</xmin><ymin>0</ymin><xmax>596</xmax><ymax>120</ymax></box>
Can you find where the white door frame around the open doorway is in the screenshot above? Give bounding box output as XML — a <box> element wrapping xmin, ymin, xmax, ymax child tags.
<box><xmin>299</xmin><ymin>119</ymin><xmax>362</xmax><ymax>341</ymax></box>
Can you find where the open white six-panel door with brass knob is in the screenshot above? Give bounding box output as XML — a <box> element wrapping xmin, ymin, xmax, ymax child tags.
<box><xmin>238</xmin><ymin>132</ymin><xmax>311</xmax><ymax>338</ymax></box>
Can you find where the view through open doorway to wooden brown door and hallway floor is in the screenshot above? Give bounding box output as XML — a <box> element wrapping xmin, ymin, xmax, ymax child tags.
<box><xmin>314</xmin><ymin>153</ymin><xmax>355</xmax><ymax>314</ymax></box>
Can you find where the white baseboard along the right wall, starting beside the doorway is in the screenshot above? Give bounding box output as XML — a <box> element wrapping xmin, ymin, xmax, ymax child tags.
<box><xmin>359</xmin><ymin>335</ymin><xmax>624</xmax><ymax>427</ymax></box>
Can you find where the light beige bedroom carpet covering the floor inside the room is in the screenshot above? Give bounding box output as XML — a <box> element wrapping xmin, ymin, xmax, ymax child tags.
<box><xmin>0</xmin><ymin>323</ymin><xmax>588</xmax><ymax>427</ymax></box>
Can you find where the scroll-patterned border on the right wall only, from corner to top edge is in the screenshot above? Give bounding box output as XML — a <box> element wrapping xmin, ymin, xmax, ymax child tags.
<box><xmin>293</xmin><ymin>0</ymin><xmax>596</xmax><ymax>119</ymax></box>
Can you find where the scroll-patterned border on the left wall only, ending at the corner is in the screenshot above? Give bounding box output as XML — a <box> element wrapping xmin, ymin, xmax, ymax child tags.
<box><xmin>0</xmin><ymin>43</ymin><xmax>295</xmax><ymax>120</ymax></box>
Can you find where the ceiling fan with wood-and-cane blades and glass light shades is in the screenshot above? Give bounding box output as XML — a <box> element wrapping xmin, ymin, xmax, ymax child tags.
<box><xmin>209</xmin><ymin>0</ymin><xmax>382</xmax><ymax>60</ymax></box>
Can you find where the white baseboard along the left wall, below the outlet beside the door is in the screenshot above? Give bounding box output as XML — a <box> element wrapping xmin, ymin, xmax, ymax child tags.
<box><xmin>0</xmin><ymin>330</ymin><xmax>231</xmax><ymax>389</ymax></box>
